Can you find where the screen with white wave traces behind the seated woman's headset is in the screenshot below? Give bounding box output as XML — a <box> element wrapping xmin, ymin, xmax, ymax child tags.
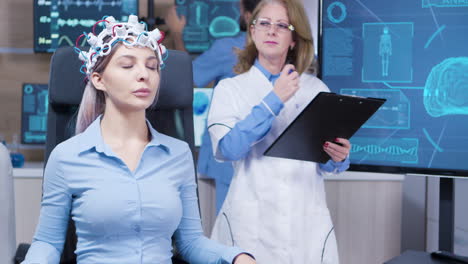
<box><xmin>34</xmin><ymin>0</ymin><xmax>138</xmax><ymax>52</ymax></box>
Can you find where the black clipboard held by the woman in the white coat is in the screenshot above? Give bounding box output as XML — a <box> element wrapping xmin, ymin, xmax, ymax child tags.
<box><xmin>264</xmin><ymin>92</ymin><xmax>386</xmax><ymax>163</ymax></box>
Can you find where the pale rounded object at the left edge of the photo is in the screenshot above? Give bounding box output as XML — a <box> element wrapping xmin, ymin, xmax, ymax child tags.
<box><xmin>0</xmin><ymin>142</ymin><xmax>16</xmax><ymax>264</ymax></box>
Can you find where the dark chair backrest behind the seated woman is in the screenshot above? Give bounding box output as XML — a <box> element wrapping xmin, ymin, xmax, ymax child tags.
<box><xmin>45</xmin><ymin>47</ymin><xmax>194</xmax><ymax>263</ymax></box>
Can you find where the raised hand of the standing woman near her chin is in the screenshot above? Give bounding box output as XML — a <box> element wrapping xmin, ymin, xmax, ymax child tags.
<box><xmin>273</xmin><ymin>64</ymin><xmax>299</xmax><ymax>103</ymax></box>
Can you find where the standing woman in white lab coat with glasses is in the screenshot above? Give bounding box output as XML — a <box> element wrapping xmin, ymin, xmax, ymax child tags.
<box><xmin>208</xmin><ymin>0</ymin><xmax>350</xmax><ymax>264</ymax></box>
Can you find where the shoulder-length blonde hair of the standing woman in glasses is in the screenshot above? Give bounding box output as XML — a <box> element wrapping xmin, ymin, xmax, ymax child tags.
<box><xmin>234</xmin><ymin>0</ymin><xmax>314</xmax><ymax>74</ymax></box>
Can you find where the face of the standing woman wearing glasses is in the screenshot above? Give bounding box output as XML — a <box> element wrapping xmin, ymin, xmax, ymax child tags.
<box><xmin>250</xmin><ymin>3</ymin><xmax>295</xmax><ymax>62</ymax></box>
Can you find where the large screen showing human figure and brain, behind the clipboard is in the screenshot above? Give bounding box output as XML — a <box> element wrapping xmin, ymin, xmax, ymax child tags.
<box><xmin>320</xmin><ymin>0</ymin><xmax>468</xmax><ymax>176</ymax></box>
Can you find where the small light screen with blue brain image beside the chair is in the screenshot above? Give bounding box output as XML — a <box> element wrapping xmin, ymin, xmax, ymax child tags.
<box><xmin>193</xmin><ymin>88</ymin><xmax>213</xmax><ymax>147</ymax></box>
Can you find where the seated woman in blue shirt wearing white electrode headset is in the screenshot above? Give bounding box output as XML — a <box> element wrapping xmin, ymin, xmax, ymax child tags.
<box><xmin>23</xmin><ymin>16</ymin><xmax>255</xmax><ymax>264</ymax></box>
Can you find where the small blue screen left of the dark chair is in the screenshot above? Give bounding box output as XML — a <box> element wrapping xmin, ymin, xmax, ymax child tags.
<box><xmin>21</xmin><ymin>83</ymin><xmax>49</xmax><ymax>144</ymax></box>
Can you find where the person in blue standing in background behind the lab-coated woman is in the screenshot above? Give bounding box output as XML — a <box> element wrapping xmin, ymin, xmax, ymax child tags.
<box><xmin>165</xmin><ymin>0</ymin><xmax>260</xmax><ymax>212</ymax></box>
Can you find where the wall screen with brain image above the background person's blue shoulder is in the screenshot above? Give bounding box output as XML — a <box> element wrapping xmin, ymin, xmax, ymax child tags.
<box><xmin>176</xmin><ymin>0</ymin><xmax>240</xmax><ymax>53</ymax></box>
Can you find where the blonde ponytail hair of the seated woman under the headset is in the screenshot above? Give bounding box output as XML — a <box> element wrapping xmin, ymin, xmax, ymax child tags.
<box><xmin>75</xmin><ymin>42</ymin><xmax>160</xmax><ymax>134</ymax></box>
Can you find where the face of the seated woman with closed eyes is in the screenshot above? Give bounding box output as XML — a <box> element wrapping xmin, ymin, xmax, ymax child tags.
<box><xmin>91</xmin><ymin>45</ymin><xmax>160</xmax><ymax>112</ymax></box>
